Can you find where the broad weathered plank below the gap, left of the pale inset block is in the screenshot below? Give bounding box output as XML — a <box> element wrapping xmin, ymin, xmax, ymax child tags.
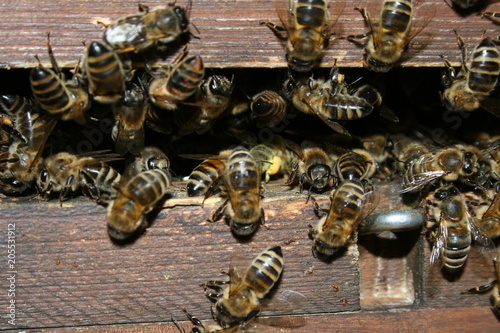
<box><xmin>0</xmin><ymin>186</ymin><xmax>360</xmax><ymax>329</ymax></box>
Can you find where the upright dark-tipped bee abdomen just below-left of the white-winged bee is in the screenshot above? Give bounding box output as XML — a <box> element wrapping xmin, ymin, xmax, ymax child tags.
<box><xmin>83</xmin><ymin>42</ymin><xmax>126</xmax><ymax>104</ymax></box>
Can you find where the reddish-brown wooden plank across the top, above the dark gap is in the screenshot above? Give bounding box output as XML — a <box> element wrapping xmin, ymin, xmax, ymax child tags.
<box><xmin>0</xmin><ymin>0</ymin><xmax>499</xmax><ymax>68</ymax></box>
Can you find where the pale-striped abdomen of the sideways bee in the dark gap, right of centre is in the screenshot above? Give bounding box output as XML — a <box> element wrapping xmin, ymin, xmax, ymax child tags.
<box><xmin>325</xmin><ymin>94</ymin><xmax>373</xmax><ymax>120</ymax></box>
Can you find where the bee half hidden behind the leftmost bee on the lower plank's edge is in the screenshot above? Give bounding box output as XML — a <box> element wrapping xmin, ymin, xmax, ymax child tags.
<box><xmin>121</xmin><ymin>146</ymin><xmax>170</xmax><ymax>182</ymax></box>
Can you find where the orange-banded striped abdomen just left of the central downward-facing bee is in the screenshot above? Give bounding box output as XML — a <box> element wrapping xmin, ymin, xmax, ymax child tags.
<box><xmin>186</xmin><ymin>160</ymin><xmax>225</xmax><ymax>197</ymax></box>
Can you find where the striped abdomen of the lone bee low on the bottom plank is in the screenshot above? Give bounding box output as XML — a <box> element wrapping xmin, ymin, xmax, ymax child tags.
<box><xmin>245</xmin><ymin>246</ymin><xmax>284</xmax><ymax>298</ymax></box>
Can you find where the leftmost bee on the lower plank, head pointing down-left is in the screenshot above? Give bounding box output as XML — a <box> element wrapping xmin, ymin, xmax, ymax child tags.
<box><xmin>107</xmin><ymin>169</ymin><xmax>170</xmax><ymax>240</ymax></box>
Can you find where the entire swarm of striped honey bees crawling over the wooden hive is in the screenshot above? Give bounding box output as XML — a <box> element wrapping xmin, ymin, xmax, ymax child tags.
<box><xmin>0</xmin><ymin>0</ymin><xmax>500</xmax><ymax>332</ymax></box>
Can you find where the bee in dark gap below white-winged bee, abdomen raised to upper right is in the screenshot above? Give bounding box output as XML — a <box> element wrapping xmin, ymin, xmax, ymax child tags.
<box><xmin>149</xmin><ymin>48</ymin><xmax>205</xmax><ymax>110</ymax></box>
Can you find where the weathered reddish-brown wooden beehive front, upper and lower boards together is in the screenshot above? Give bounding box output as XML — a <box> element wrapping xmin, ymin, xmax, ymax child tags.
<box><xmin>0</xmin><ymin>0</ymin><xmax>500</xmax><ymax>332</ymax></box>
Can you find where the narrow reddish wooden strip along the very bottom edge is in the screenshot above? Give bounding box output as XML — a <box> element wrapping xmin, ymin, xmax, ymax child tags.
<box><xmin>10</xmin><ymin>307</ymin><xmax>498</xmax><ymax>333</ymax></box>
